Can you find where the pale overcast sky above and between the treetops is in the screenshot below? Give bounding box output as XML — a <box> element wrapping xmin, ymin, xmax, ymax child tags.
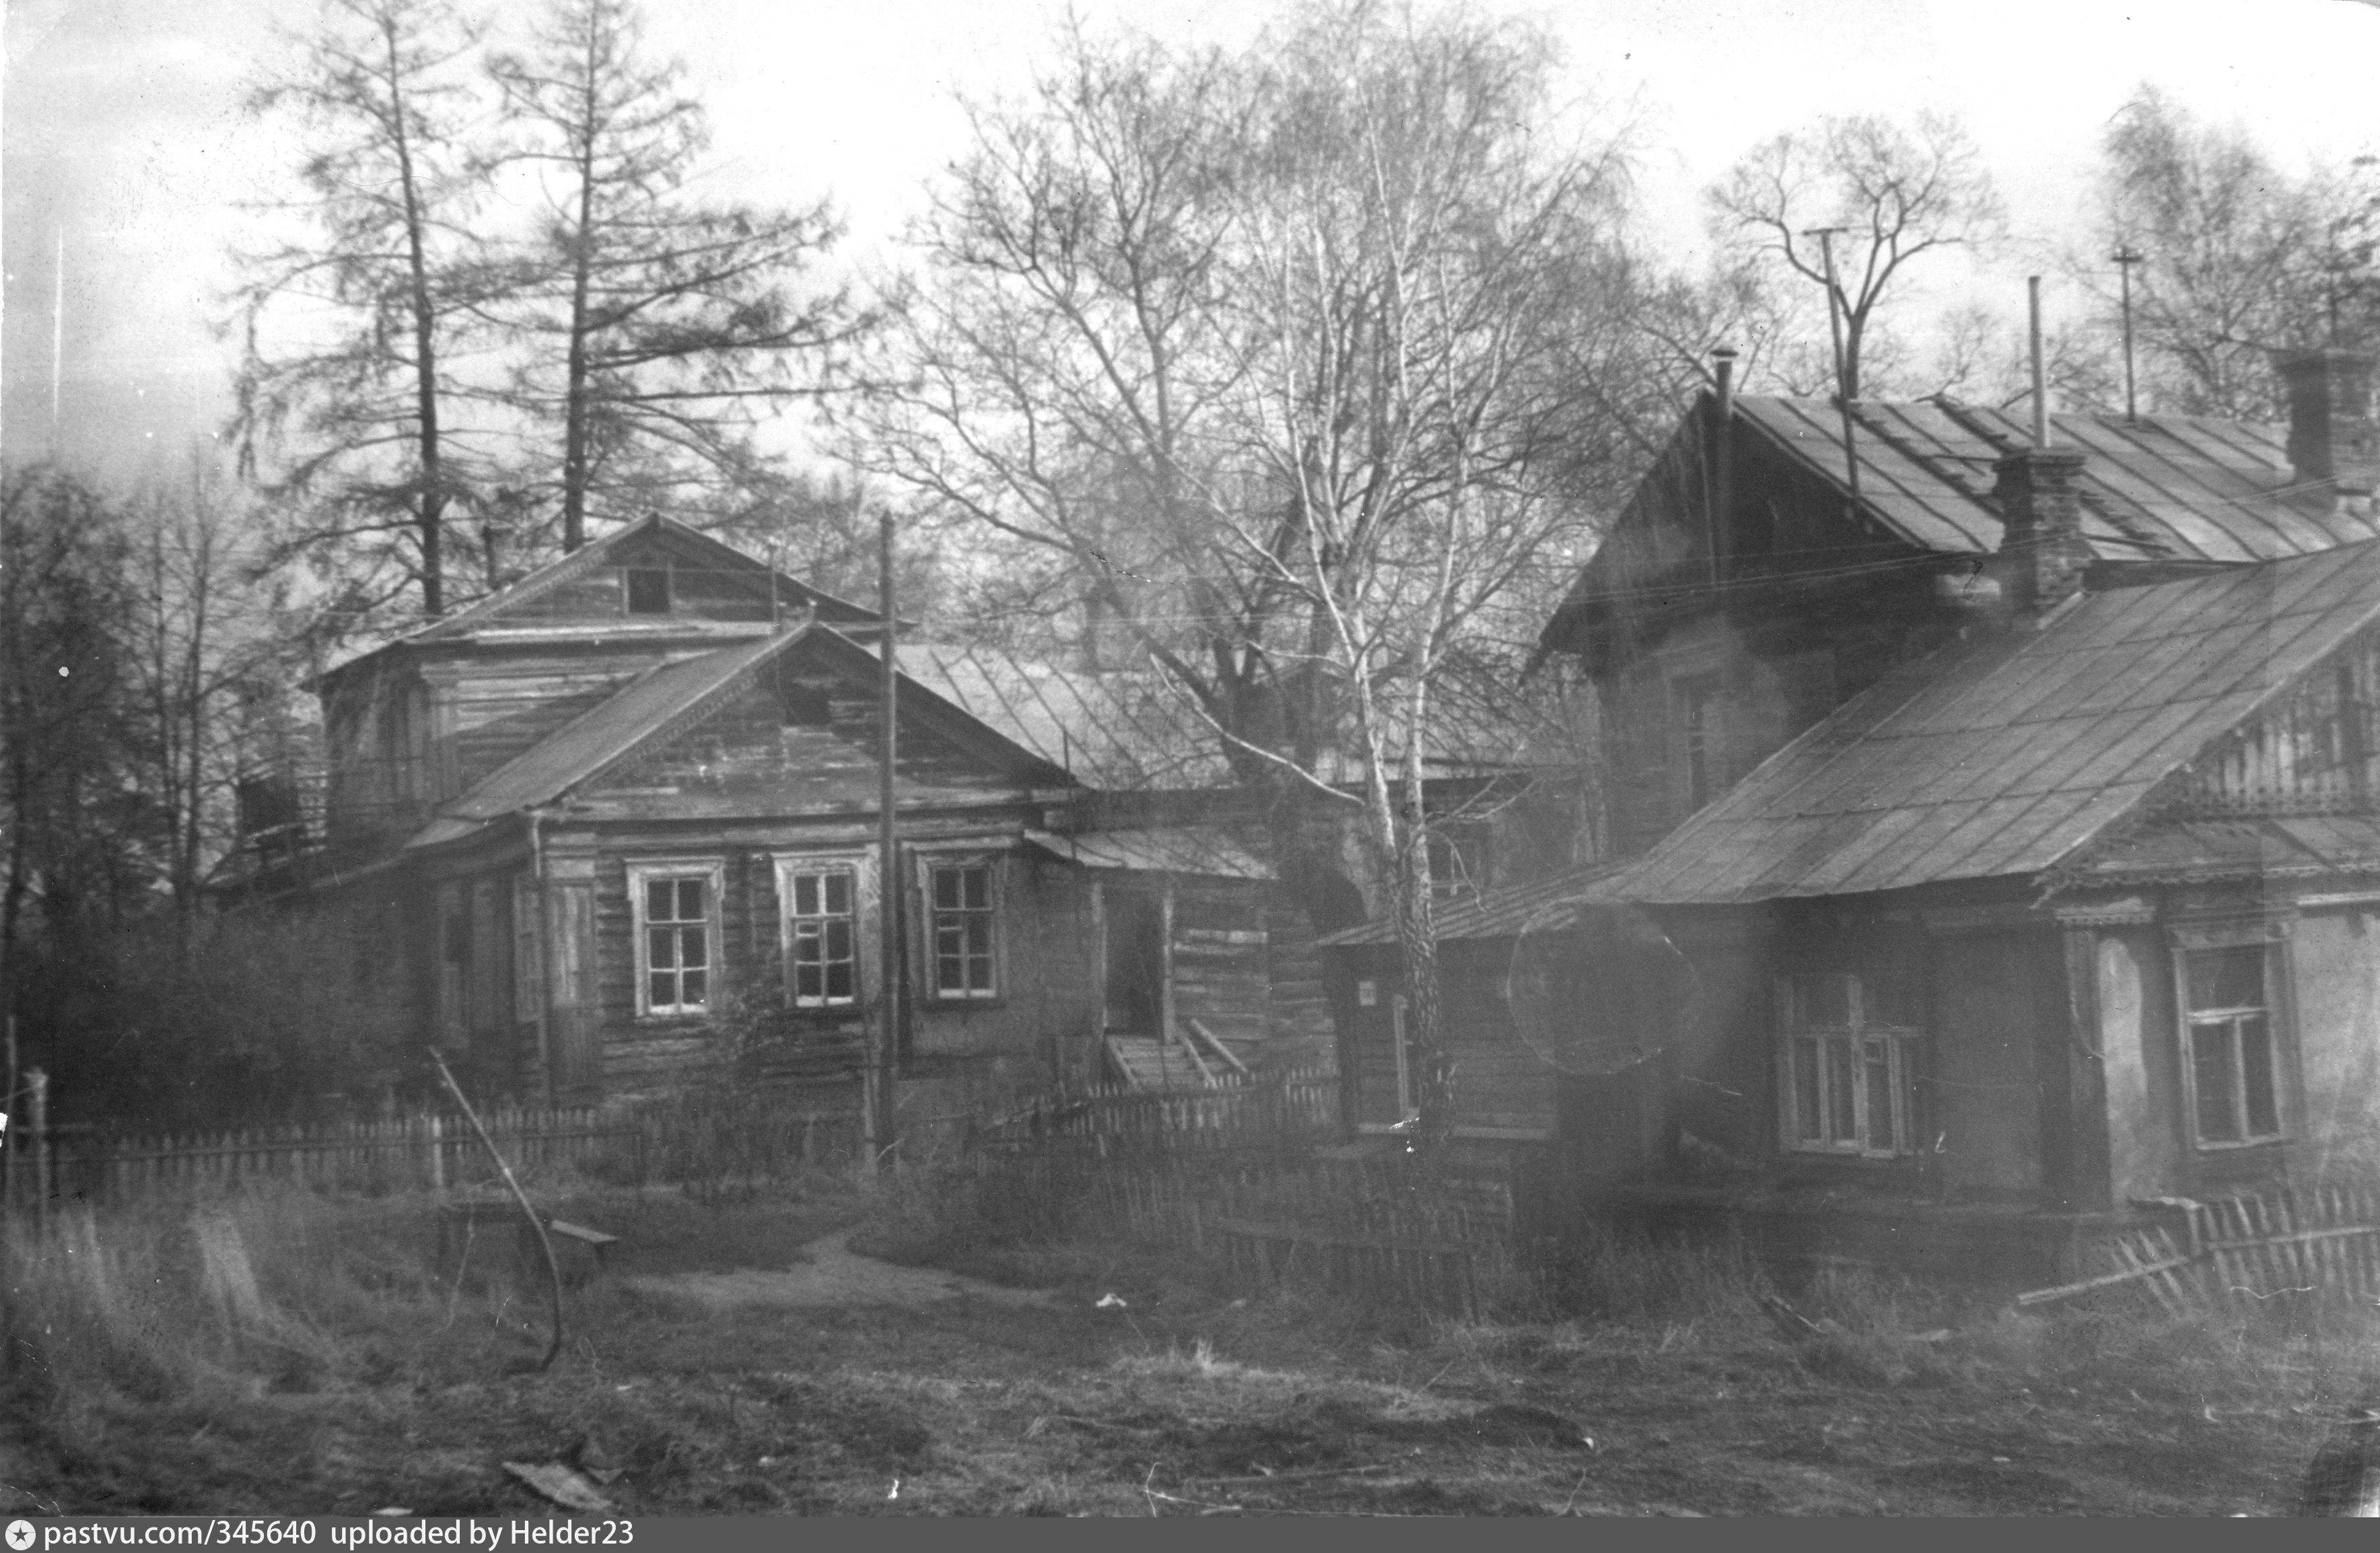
<box><xmin>13</xmin><ymin>0</ymin><xmax>2380</xmax><ymax>474</ymax></box>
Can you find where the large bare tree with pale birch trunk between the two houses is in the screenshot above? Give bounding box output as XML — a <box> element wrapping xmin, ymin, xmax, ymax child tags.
<box><xmin>862</xmin><ymin>0</ymin><xmax>1644</xmax><ymax>1138</ymax></box>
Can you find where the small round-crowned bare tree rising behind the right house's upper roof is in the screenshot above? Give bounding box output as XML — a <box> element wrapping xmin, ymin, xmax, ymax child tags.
<box><xmin>1706</xmin><ymin>114</ymin><xmax>2006</xmax><ymax>398</ymax></box>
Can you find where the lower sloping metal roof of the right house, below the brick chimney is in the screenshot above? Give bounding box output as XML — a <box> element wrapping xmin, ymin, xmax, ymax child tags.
<box><xmin>1609</xmin><ymin>543</ymin><xmax>2380</xmax><ymax>905</ymax></box>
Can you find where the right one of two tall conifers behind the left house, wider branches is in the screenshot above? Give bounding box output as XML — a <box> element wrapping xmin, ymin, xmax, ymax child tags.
<box><xmin>490</xmin><ymin>0</ymin><xmax>859</xmax><ymax>550</ymax></box>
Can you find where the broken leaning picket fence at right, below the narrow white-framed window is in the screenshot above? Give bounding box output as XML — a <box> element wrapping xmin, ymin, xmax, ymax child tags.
<box><xmin>2016</xmin><ymin>1186</ymin><xmax>2380</xmax><ymax>1317</ymax></box>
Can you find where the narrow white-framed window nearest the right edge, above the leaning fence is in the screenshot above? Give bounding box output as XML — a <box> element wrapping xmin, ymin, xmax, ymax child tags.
<box><xmin>2177</xmin><ymin>938</ymin><xmax>2282</xmax><ymax>1148</ymax></box>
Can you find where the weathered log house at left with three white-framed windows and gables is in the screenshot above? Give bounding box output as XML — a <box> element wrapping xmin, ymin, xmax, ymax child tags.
<box><xmin>283</xmin><ymin>519</ymin><xmax>1323</xmax><ymax>1101</ymax></box>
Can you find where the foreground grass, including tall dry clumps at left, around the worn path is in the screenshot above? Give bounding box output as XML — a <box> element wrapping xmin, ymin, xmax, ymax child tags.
<box><xmin>0</xmin><ymin>1177</ymin><xmax>2375</xmax><ymax>1515</ymax></box>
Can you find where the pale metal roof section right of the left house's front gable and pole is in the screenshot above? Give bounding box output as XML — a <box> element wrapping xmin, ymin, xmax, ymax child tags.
<box><xmin>897</xmin><ymin>641</ymin><xmax>1230</xmax><ymax>791</ymax></box>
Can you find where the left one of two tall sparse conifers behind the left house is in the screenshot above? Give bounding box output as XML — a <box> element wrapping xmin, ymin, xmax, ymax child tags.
<box><xmin>234</xmin><ymin>0</ymin><xmax>483</xmax><ymax>629</ymax></box>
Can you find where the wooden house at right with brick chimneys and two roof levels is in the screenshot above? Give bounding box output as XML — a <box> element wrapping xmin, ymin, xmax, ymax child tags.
<box><xmin>1333</xmin><ymin>350</ymin><xmax>2380</xmax><ymax>1282</ymax></box>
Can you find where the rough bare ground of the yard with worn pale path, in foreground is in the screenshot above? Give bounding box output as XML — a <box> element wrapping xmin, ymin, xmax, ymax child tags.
<box><xmin>0</xmin><ymin>1191</ymin><xmax>2349</xmax><ymax>1515</ymax></box>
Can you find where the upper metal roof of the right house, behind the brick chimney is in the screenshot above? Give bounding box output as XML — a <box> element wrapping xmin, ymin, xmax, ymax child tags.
<box><xmin>1735</xmin><ymin>395</ymin><xmax>2380</xmax><ymax>562</ymax></box>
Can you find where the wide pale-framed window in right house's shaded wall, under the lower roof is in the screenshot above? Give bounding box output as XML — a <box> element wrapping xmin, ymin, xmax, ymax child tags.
<box><xmin>1778</xmin><ymin>972</ymin><xmax>1923</xmax><ymax>1158</ymax></box>
